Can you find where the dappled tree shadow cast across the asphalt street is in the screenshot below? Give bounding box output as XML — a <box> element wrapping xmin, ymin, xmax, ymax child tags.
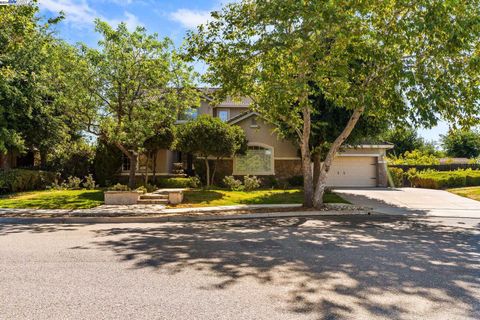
<box><xmin>86</xmin><ymin>216</ymin><xmax>480</xmax><ymax>319</ymax></box>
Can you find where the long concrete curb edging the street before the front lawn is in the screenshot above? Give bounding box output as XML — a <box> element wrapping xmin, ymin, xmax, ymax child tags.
<box><xmin>0</xmin><ymin>210</ymin><xmax>371</xmax><ymax>224</ymax></box>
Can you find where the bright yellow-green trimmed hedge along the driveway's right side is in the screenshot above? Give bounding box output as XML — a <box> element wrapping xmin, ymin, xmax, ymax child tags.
<box><xmin>409</xmin><ymin>169</ymin><xmax>480</xmax><ymax>189</ymax></box>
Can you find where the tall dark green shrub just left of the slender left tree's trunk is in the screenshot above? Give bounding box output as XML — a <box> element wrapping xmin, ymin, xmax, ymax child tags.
<box><xmin>93</xmin><ymin>141</ymin><xmax>122</xmax><ymax>186</ymax></box>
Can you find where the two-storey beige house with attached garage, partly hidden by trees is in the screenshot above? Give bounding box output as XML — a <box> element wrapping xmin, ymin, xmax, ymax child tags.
<box><xmin>122</xmin><ymin>91</ymin><xmax>393</xmax><ymax>187</ymax></box>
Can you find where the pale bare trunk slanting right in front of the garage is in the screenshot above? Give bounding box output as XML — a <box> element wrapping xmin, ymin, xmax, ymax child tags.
<box><xmin>313</xmin><ymin>107</ymin><xmax>365</xmax><ymax>208</ymax></box>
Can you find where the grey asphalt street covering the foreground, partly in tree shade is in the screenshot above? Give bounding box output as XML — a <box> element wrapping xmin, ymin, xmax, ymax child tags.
<box><xmin>0</xmin><ymin>216</ymin><xmax>480</xmax><ymax>320</ymax></box>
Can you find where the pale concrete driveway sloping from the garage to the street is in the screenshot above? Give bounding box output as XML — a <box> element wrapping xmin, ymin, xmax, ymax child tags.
<box><xmin>335</xmin><ymin>188</ymin><xmax>480</xmax><ymax>218</ymax></box>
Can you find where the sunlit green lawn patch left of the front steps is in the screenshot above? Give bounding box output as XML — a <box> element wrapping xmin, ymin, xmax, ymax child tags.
<box><xmin>0</xmin><ymin>190</ymin><xmax>103</xmax><ymax>209</ymax></box>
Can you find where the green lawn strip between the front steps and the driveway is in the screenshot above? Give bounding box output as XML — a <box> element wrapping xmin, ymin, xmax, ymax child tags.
<box><xmin>177</xmin><ymin>189</ymin><xmax>348</xmax><ymax>207</ymax></box>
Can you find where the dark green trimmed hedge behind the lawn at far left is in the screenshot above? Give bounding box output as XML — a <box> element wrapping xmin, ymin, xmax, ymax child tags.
<box><xmin>0</xmin><ymin>169</ymin><xmax>57</xmax><ymax>194</ymax></box>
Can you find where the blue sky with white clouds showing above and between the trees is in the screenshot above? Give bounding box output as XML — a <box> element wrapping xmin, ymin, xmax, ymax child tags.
<box><xmin>39</xmin><ymin>0</ymin><xmax>448</xmax><ymax>140</ymax></box>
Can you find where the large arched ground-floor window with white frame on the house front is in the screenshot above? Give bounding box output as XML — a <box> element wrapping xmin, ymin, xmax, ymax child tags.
<box><xmin>233</xmin><ymin>146</ymin><xmax>275</xmax><ymax>175</ymax></box>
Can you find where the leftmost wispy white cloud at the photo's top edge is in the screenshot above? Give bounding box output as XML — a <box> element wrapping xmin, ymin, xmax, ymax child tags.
<box><xmin>39</xmin><ymin>0</ymin><xmax>98</xmax><ymax>25</ymax></box>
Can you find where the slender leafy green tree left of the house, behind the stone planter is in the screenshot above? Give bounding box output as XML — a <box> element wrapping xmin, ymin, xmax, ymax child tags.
<box><xmin>71</xmin><ymin>20</ymin><xmax>199</xmax><ymax>188</ymax></box>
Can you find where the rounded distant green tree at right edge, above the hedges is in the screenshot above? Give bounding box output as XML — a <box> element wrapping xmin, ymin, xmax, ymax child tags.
<box><xmin>442</xmin><ymin>129</ymin><xmax>480</xmax><ymax>158</ymax></box>
